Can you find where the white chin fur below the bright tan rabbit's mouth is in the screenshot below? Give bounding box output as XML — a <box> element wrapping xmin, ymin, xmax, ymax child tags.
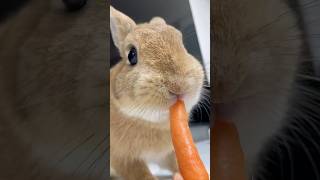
<box><xmin>120</xmin><ymin>91</ymin><xmax>200</xmax><ymax>123</ymax></box>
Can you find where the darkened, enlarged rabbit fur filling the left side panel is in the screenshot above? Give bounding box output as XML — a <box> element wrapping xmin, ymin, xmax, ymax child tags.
<box><xmin>0</xmin><ymin>0</ymin><xmax>109</xmax><ymax>180</ymax></box>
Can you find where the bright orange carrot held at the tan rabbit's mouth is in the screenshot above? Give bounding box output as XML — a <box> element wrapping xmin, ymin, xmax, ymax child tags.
<box><xmin>170</xmin><ymin>99</ymin><xmax>209</xmax><ymax>180</ymax></box>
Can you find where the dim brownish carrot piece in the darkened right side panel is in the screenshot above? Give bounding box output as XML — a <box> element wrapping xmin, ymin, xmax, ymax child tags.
<box><xmin>211</xmin><ymin>118</ymin><xmax>247</xmax><ymax>180</ymax></box>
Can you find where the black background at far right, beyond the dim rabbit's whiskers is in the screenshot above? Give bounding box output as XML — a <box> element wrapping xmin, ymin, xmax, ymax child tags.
<box><xmin>254</xmin><ymin>0</ymin><xmax>320</xmax><ymax>180</ymax></box>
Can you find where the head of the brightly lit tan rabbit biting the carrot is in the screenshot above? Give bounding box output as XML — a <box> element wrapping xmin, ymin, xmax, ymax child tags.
<box><xmin>111</xmin><ymin>6</ymin><xmax>204</xmax><ymax>122</ymax></box>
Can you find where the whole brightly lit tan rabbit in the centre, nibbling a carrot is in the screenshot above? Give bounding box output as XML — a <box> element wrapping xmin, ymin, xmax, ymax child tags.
<box><xmin>110</xmin><ymin>6</ymin><xmax>204</xmax><ymax>180</ymax></box>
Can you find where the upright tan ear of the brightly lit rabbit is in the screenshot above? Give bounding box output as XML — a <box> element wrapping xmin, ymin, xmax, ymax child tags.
<box><xmin>110</xmin><ymin>6</ymin><xmax>136</xmax><ymax>50</ymax></box>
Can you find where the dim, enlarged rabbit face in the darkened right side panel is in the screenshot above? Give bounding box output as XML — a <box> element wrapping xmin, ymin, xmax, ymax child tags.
<box><xmin>211</xmin><ymin>0</ymin><xmax>303</xmax><ymax>176</ymax></box>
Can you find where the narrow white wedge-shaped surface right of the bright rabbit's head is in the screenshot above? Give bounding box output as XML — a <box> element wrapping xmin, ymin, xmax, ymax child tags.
<box><xmin>189</xmin><ymin>0</ymin><xmax>210</xmax><ymax>83</ymax></box>
